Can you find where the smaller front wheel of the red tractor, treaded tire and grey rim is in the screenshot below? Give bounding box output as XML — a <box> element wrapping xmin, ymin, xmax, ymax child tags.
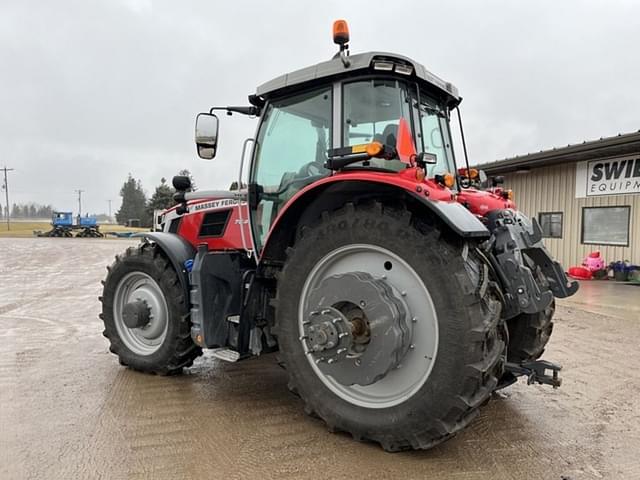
<box><xmin>100</xmin><ymin>243</ymin><xmax>202</xmax><ymax>375</ymax></box>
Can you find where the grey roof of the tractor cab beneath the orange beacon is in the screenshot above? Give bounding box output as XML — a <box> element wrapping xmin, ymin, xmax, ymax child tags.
<box><xmin>256</xmin><ymin>52</ymin><xmax>462</xmax><ymax>106</ymax></box>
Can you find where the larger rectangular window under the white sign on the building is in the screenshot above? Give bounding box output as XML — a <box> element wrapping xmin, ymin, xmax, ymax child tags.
<box><xmin>582</xmin><ymin>206</ymin><xmax>631</xmax><ymax>247</ymax></box>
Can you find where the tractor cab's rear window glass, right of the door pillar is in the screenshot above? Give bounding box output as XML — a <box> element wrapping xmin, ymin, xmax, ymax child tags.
<box><xmin>342</xmin><ymin>79</ymin><xmax>455</xmax><ymax>178</ymax></box>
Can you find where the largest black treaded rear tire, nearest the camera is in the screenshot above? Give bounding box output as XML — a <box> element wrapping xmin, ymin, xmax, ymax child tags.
<box><xmin>274</xmin><ymin>203</ymin><xmax>505</xmax><ymax>451</ymax></box>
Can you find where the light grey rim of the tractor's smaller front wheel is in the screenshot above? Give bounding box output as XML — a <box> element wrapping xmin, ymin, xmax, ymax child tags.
<box><xmin>113</xmin><ymin>272</ymin><xmax>169</xmax><ymax>355</ymax></box>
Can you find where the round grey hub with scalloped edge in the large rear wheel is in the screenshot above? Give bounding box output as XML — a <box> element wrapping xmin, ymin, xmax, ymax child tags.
<box><xmin>300</xmin><ymin>272</ymin><xmax>413</xmax><ymax>386</ymax></box>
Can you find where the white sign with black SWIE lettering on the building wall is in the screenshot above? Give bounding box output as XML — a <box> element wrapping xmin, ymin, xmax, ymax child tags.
<box><xmin>576</xmin><ymin>155</ymin><xmax>640</xmax><ymax>198</ymax></box>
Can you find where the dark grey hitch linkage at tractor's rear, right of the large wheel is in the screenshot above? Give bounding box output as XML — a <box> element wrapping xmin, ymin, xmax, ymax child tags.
<box><xmin>486</xmin><ymin>209</ymin><xmax>578</xmax><ymax>318</ymax></box>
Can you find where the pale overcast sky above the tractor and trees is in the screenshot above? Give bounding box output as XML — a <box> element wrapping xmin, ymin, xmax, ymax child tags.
<box><xmin>0</xmin><ymin>0</ymin><xmax>640</xmax><ymax>213</ymax></box>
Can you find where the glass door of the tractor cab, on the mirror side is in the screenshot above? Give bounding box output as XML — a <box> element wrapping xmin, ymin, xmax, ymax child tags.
<box><xmin>250</xmin><ymin>86</ymin><xmax>332</xmax><ymax>252</ymax></box>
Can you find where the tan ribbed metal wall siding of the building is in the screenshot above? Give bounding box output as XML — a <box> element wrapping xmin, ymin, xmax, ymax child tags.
<box><xmin>504</xmin><ymin>163</ymin><xmax>640</xmax><ymax>270</ymax></box>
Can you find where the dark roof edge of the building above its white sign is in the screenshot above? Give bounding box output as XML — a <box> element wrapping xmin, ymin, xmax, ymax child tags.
<box><xmin>476</xmin><ymin>130</ymin><xmax>640</xmax><ymax>175</ymax></box>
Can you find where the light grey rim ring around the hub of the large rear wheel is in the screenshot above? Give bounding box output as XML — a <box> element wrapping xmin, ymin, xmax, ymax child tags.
<box><xmin>298</xmin><ymin>244</ymin><xmax>438</xmax><ymax>408</ymax></box>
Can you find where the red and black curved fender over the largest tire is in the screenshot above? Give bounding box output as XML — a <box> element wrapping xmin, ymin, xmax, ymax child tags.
<box><xmin>261</xmin><ymin>179</ymin><xmax>490</xmax><ymax>262</ymax></box>
